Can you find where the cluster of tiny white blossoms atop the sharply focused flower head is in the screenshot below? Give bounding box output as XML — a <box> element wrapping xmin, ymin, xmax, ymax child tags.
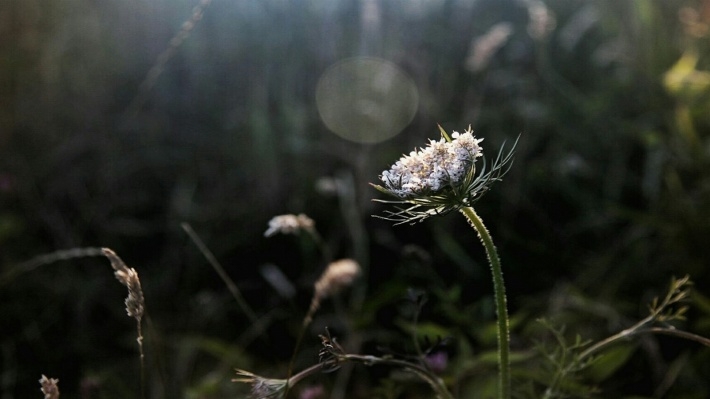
<box><xmin>380</xmin><ymin>126</ymin><xmax>483</xmax><ymax>199</ymax></box>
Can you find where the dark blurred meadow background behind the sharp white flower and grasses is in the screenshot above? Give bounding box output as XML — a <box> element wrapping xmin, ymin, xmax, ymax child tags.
<box><xmin>0</xmin><ymin>0</ymin><xmax>710</xmax><ymax>399</ymax></box>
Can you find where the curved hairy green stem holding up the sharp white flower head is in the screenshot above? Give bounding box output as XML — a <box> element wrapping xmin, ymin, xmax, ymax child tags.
<box><xmin>461</xmin><ymin>207</ymin><xmax>510</xmax><ymax>399</ymax></box>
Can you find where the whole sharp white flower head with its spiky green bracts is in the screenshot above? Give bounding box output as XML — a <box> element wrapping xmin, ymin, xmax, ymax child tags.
<box><xmin>373</xmin><ymin>126</ymin><xmax>517</xmax><ymax>224</ymax></box>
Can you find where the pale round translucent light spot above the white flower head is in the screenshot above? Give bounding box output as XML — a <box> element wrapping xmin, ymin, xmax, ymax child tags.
<box><xmin>316</xmin><ymin>57</ymin><xmax>419</xmax><ymax>143</ymax></box>
